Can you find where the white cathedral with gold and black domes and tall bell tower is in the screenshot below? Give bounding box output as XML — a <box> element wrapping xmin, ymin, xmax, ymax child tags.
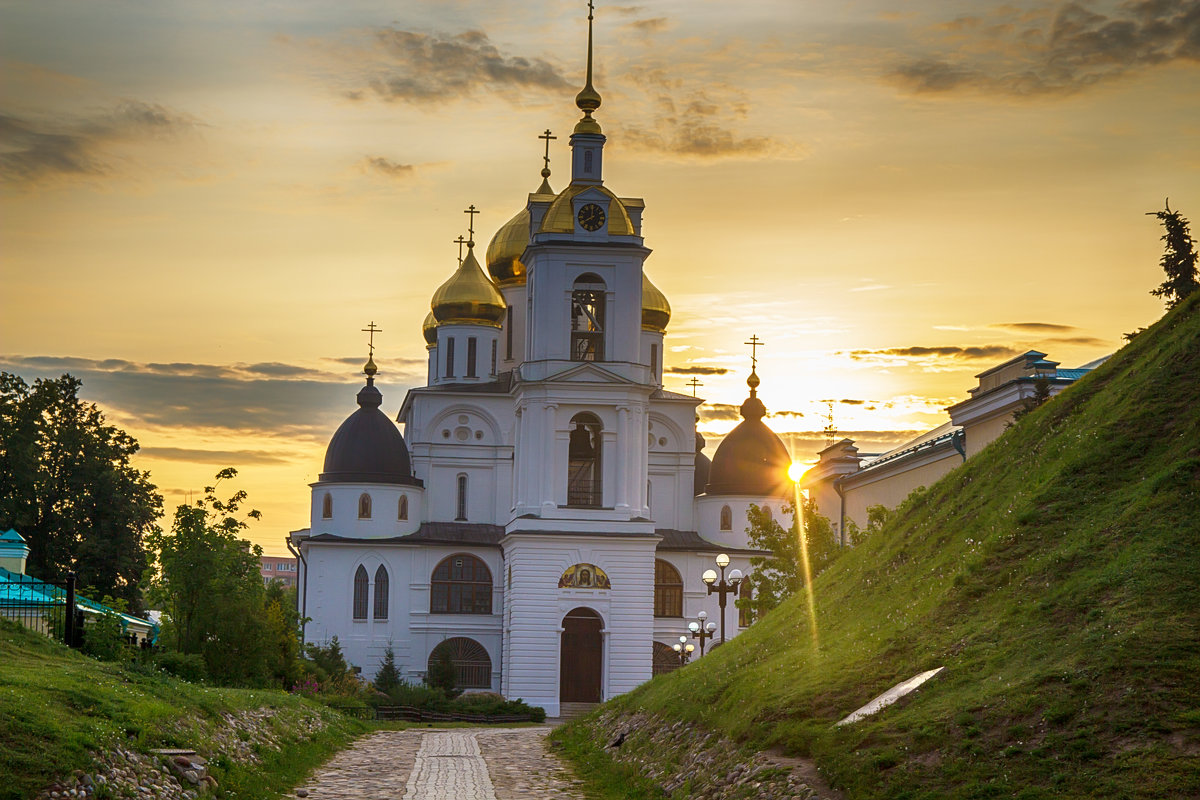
<box><xmin>288</xmin><ymin>17</ymin><xmax>792</xmax><ymax>716</ymax></box>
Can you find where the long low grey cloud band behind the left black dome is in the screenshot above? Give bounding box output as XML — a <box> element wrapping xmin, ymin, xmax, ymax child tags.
<box><xmin>0</xmin><ymin>356</ymin><xmax>424</xmax><ymax>440</ymax></box>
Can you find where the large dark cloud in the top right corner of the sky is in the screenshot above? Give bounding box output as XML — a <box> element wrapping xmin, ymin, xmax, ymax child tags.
<box><xmin>890</xmin><ymin>0</ymin><xmax>1200</xmax><ymax>96</ymax></box>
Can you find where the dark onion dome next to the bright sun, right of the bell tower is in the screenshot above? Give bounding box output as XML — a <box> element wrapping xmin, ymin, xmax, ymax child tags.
<box><xmin>706</xmin><ymin>373</ymin><xmax>792</xmax><ymax>497</ymax></box>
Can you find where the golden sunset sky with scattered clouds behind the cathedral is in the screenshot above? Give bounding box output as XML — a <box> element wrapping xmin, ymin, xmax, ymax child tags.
<box><xmin>0</xmin><ymin>0</ymin><xmax>1200</xmax><ymax>554</ymax></box>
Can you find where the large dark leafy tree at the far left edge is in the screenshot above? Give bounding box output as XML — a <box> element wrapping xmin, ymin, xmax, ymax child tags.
<box><xmin>0</xmin><ymin>372</ymin><xmax>162</xmax><ymax>608</ymax></box>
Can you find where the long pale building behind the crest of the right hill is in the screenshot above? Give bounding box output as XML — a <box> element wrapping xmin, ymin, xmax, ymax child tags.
<box><xmin>800</xmin><ymin>350</ymin><xmax>1103</xmax><ymax>539</ymax></box>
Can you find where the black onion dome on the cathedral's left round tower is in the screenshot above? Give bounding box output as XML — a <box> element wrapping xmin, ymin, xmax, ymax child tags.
<box><xmin>319</xmin><ymin>377</ymin><xmax>420</xmax><ymax>486</ymax></box>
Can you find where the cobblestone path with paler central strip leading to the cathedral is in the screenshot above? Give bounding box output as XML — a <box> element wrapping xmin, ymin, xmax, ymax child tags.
<box><xmin>296</xmin><ymin>728</ymin><xmax>582</xmax><ymax>800</ymax></box>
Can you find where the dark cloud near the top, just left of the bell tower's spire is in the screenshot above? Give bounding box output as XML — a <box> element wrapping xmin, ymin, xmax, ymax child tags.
<box><xmin>349</xmin><ymin>28</ymin><xmax>570</xmax><ymax>104</ymax></box>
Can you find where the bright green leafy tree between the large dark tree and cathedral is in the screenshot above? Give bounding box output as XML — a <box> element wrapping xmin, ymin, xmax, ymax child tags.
<box><xmin>148</xmin><ymin>468</ymin><xmax>290</xmax><ymax>685</ymax></box>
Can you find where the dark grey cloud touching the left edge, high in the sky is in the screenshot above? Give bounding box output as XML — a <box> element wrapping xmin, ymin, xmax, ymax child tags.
<box><xmin>0</xmin><ymin>101</ymin><xmax>196</xmax><ymax>184</ymax></box>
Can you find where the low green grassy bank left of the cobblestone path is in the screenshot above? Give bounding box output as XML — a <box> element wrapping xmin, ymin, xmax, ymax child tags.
<box><xmin>0</xmin><ymin>621</ymin><xmax>368</xmax><ymax>800</ymax></box>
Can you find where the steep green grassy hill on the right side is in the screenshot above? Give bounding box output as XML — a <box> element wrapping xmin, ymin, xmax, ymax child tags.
<box><xmin>568</xmin><ymin>295</ymin><xmax>1200</xmax><ymax>800</ymax></box>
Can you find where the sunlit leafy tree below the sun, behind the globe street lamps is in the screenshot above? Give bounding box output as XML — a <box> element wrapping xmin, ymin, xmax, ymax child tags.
<box><xmin>737</xmin><ymin>498</ymin><xmax>839</xmax><ymax>616</ymax></box>
